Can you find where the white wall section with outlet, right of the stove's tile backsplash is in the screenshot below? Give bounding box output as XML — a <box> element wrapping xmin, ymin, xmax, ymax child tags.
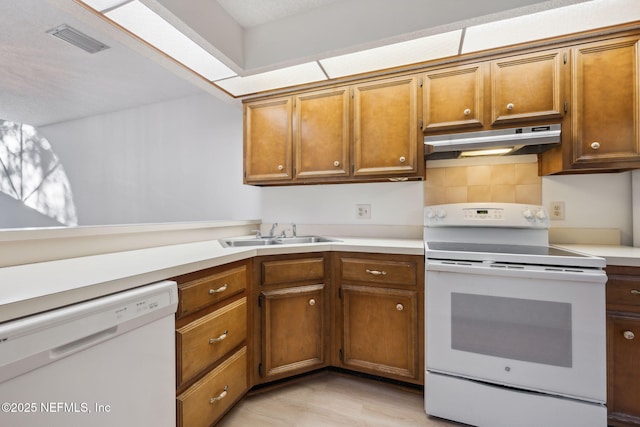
<box><xmin>542</xmin><ymin>172</ymin><xmax>633</xmax><ymax>245</ymax></box>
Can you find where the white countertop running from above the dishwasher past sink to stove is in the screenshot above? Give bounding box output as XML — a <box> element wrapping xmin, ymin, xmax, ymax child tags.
<box><xmin>0</xmin><ymin>236</ymin><xmax>424</xmax><ymax>322</ymax></box>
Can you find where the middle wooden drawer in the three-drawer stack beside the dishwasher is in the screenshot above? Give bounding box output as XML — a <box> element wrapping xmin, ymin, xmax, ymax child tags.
<box><xmin>176</xmin><ymin>297</ymin><xmax>247</xmax><ymax>385</ymax></box>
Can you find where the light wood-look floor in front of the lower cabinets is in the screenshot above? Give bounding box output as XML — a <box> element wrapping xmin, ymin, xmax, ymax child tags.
<box><xmin>219</xmin><ymin>372</ymin><xmax>463</xmax><ymax>427</ymax></box>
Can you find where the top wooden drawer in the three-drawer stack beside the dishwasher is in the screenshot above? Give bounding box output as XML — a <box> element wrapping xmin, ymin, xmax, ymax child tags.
<box><xmin>178</xmin><ymin>265</ymin><xmax>247</xmax><ymax>317</ymax></box>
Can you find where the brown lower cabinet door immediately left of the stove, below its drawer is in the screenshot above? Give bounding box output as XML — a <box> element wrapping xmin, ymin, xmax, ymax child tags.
<box><xmin>342</xmin><ymin>285</ymin><xmax>418</xmax><ymax>380</ymax></box>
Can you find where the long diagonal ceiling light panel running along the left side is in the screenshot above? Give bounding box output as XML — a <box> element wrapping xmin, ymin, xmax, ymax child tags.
<box><xmin>85</xmin><ymin>0</ymin><xmax>236</xmax><ymax>81</ymax></box>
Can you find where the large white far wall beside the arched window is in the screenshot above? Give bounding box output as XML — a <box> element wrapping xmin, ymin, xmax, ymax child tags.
<box><xmin>39</xmin><ymin>94</ymin><xmax>260</xmax><ymax>225</ymax></box>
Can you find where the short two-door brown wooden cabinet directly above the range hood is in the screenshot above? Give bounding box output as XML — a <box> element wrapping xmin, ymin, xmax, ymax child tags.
<box><xmin>423</xmin><ymin>50</ymin><xmax>566</xmax><ymax>132</ymax></box>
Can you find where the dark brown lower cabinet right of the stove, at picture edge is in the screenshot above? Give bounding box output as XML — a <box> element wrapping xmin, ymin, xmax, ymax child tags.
<box><xmin>607</xmin><ymin>266</ymin><xmax>640</xmax><ymax>427</ymax></box>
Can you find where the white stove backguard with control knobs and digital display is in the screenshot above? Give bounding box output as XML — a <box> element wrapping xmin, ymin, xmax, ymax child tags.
<box><xmin>424</xmin><ymin>203</ymin><xmax>549</xmax><ymax>228</ymax></box>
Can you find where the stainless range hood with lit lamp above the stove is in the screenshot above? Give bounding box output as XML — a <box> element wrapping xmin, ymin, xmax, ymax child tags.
<box><xmin>424</xmin><ymin>124</ymin><xmax>562</xmax><ymax>160</ymax></box>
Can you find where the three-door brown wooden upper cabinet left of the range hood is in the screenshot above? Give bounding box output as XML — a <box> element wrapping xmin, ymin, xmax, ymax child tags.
<box><xmin>244</xmin><ymin>76</ymin><xmax>424</xmax><ymax>185</ymax></box>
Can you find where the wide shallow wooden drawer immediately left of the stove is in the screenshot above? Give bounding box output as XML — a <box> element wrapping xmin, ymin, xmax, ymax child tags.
<box><xmin>340</xmin><ymin>258</ymin><xmax>424</xmax><ymax>286</ymax></box>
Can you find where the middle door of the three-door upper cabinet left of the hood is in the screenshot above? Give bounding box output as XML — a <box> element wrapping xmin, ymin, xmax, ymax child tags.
<box><xmin>294</xmin><ymin>88</ymin><xmax>349</xmax><ymax>179</ymax></box>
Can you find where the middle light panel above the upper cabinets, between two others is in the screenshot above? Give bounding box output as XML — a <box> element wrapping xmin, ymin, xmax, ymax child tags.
<box><xmin>320</xmin><ymin>30</ymin><xmax>462</xmax><ymax>79</ymax></box>
